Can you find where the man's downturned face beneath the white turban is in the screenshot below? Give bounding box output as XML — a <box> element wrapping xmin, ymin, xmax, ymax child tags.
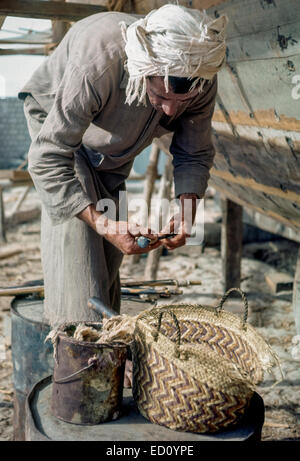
<box><xmin>147</xmin><ymin>77</ymin><xmax>198</xmax><ymax>117</ymax></box>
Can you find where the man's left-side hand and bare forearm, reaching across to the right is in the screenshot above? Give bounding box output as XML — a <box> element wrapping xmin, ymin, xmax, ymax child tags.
<box><xmin>77</xmin><ymin>205</ymin><xmax>162</xmax><ymax>255</ymax></box>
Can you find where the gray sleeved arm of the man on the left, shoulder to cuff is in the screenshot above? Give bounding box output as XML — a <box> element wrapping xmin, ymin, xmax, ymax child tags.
<box><xmin>28</xmin><ymin>63</ymin><xmax>101</xmax><ymax>224</ymax></box>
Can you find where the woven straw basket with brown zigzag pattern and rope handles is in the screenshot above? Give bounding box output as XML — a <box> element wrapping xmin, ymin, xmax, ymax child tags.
<box><xmin>132</xmin><ymin>288</ymin><xmax>278</xmax><ymax>433</ymax></box>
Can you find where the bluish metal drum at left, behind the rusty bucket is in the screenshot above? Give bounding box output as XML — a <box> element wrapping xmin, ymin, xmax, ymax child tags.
<box><xmin>11</xmin><ymin>296</ymin><xmax>54</xmax><ymax>441</ymax></box>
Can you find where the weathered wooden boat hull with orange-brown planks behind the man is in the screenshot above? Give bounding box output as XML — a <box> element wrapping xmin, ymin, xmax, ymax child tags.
<box><xmin>155</xmin><ymin>0</ymin><xmax>300</xmax><ymax>233</ymax></box>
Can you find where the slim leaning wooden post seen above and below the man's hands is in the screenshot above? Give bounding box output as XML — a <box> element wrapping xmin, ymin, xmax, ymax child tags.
<box><xmin>144</xmin><ymin>154</ymin><xmax>173</xmax><ymax>280</ymax></box>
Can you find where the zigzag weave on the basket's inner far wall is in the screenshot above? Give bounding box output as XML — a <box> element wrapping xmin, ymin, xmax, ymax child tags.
<box><xmin>153</xmin><ymin>319</ymin><xmax>261</xmax><ymax>381</ymax></box>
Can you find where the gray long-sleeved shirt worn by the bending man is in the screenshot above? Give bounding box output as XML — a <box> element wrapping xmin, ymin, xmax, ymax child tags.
<box><xmin>19</xmin><ymin>12</ymin><xmax>217</xmax><ymax>224</ymax></box>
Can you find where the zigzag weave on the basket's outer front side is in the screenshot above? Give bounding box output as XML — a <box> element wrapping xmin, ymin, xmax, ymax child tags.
<box><xmin>133</xmin><ymin>340</ymin><xmax>252</xmax><ymax>433</ymax></box>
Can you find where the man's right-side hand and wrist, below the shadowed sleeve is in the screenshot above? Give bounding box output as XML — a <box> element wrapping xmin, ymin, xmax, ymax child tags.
<box><xmin>159</xmin><ymin>194</ymin><xmax>199</xmax><ymax>250</ymax></box>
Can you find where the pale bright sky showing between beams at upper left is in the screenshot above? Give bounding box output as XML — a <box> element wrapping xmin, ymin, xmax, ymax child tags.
<box><xmin>0</xmin><ymin>17</ymin><xmax>51</xmax><ymax>97</ymax></box>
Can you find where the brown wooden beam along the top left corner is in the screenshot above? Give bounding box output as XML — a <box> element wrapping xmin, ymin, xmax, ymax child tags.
<box><xmin>0</xmin><ymin>0</ymin><xmax>107</xmax><ymax>21</ymax></box>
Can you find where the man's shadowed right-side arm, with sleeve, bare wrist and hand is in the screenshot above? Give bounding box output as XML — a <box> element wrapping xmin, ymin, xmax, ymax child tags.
<box><xmin>162</xmin><ymin>77</ymin><xmax>217</xmax><ymax>250</ymax></box>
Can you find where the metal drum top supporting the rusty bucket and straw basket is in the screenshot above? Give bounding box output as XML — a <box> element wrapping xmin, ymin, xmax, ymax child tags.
<box><xmin>26</xmin><ymin>376</ymin><xmax>264</xmax><ymax>442</ymax></box>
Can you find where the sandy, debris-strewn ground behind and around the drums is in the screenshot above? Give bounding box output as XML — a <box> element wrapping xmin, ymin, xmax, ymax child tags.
<box><xmin>0</xmin><ymin>185</ymin><xmax>300</xmax><ymax>441</ymax></box>
